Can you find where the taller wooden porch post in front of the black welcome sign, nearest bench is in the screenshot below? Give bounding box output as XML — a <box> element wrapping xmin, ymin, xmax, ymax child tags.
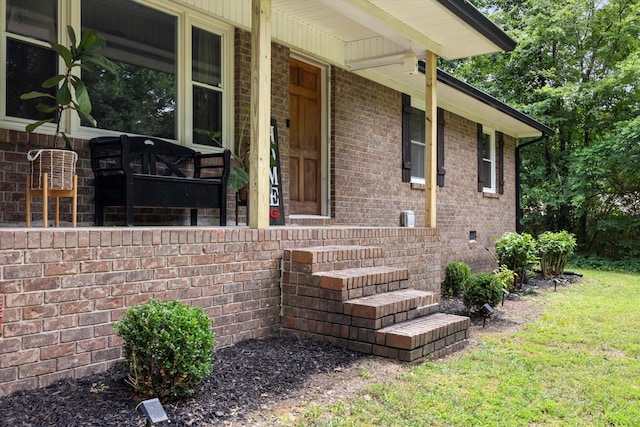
<box><xmin>249</xmin><ymin>0</ymin><xmax>271</xmax><ymax>228</ymax></box>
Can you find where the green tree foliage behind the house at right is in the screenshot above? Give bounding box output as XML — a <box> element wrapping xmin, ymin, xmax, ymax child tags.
<box><xmin>441</xmin><ymin>0</ymin><xmax>640</xmax><ymax>258</ymax></box>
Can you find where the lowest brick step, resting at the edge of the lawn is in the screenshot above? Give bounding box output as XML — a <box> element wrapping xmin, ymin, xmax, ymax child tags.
<box><xmin>373</xmin><ymin>313</ymin><xmax>470</xmax><ymax>362</ymax></box>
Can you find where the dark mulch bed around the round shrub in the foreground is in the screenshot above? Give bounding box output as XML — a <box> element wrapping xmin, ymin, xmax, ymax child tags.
<box><xmin>0</xmin><ymin>338</ymin><xmax>362</xmax><ymax>427</ymax></box>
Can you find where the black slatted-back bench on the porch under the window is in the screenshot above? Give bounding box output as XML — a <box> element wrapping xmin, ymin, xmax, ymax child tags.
<box><xmin>90</xmin><ymin>135</ymin><xmax>231</xmax><ymax>226</ymax></box>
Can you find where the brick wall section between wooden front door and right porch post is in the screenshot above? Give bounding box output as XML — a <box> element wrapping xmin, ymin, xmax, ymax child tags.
<box><xmin>331</xmin><ymin>68</ymin><xmax>424</xmax><ymax>226</ymax></box>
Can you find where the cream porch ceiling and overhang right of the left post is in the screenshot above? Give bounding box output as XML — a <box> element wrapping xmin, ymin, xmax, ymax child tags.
<box><xmin>272</xmin><ymin>0</ymin><xmax>515</xmax><ymax>65</ymax></box>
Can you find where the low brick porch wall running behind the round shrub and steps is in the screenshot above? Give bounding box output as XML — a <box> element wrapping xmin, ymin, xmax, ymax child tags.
<box><xmin>0</xmin><ymin>227</ymin><xmax>440</xmax><ymax>396</ymax></box>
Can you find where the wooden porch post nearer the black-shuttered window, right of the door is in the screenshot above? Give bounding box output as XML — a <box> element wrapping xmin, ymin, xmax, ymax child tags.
<box><xmin>424</xmin><ymin>50</ymin><xmax>438</xmax><ymax>227</ymax></box>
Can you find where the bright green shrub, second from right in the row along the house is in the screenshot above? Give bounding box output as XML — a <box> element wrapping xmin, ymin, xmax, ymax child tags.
<box><xmin>496</xmin><ymin>232</ymin><xmax>537</xmax><ymax>287</ymax></box>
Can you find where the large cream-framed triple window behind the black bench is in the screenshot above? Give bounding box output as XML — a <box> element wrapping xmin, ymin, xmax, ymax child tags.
<box><xmin>3</xmin><ymin>0</ymin><xmax>233</xmax><ymax>146</ymax></box>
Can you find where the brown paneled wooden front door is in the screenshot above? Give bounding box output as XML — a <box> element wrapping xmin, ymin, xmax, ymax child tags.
<box><xmin>289</xmin><ymin>58</ymin><xmax>322</xmax><ymax>215</ymax></box>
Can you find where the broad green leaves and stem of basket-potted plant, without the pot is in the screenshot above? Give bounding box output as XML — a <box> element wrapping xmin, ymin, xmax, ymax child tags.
<box><xmin>20</xmin><ymin>26</ymin><xmax>116</xmax><ymax>149</ymax></box>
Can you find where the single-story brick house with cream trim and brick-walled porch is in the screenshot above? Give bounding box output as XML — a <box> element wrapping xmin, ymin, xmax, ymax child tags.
<box><xmin>0</xmin><ymin>0</ymin><xmax>553</xmax><ymax>395</ymax></box>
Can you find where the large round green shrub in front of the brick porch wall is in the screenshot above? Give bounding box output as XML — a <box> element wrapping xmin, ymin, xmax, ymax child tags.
<box><xmin>114</xmin><ymin>300</ymin><xmax>215</xmax><ymax>399</ymax></box>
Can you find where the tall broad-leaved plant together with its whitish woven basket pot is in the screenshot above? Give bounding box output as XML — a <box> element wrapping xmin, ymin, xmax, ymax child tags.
<box><xmin>20</xmin><ymin>26</ymin><xmax>115</xmax><ymax>190</ymax></box>
